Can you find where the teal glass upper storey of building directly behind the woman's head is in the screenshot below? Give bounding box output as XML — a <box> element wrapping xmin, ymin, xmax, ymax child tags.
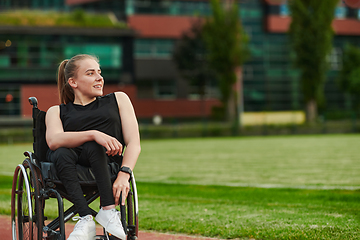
<box><xmin>0</xmin><ymin>32</ymin><xmax>130</xmax><ymax>83</ymax></box>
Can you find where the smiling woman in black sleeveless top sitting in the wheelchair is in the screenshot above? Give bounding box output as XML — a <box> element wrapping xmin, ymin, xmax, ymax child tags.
<box><xmin>45</xmin><ymin>54</ymin><xmax>140</xmax><ymax>240</ymax></box>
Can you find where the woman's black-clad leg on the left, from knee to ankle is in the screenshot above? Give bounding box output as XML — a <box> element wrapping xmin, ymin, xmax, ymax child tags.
<box><xmin>48</xmin><ymin>148</ymin><xmax>91</xmax><ymax>217</ymax></box>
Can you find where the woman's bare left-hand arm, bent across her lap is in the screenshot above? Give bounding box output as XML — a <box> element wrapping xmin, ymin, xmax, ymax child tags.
<box><xmin>45</xmin><ymin>106</ymin><xmax>122</xmax><ymax>156</ymax></box>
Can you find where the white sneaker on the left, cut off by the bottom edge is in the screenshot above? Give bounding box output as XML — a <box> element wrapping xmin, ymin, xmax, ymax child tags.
<box><xmin>67</xmin><ymin>215</ymin><xmax>96</xmax><ymax>240</ymax></box>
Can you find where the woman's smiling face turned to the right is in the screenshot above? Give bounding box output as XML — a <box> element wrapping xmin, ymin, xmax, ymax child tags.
<box><xmin>69</xmin><ymin>58</ymin><xmax>104</xmax><ymax>100</ymax></box>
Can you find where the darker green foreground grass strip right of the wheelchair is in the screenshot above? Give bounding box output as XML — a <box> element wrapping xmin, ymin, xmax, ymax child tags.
<box><xmin>139</xmin><ymin>183</ymin><xmax>360</xmax><ymax>240</ymax></box>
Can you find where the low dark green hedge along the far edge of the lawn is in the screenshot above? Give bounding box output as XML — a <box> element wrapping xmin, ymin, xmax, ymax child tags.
<box><xmin>0</xmin><ymin>121</ymin><xmax>360</xmax><ymax>143</ymax></box>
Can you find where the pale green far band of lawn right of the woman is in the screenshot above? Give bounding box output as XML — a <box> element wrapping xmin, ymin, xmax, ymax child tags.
<box><xmin>135</xmin><ymin>135</ymin><xmax>360</xmax><ymax>187</ymax></box>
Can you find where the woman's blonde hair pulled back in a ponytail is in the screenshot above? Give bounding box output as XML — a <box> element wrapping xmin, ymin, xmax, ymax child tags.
<box><xmin>57</xmin><ymin>54</ymin><xmax>99</xmax><ymax>104</ymax></box>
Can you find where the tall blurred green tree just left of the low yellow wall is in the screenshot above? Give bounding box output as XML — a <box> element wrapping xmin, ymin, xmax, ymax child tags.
<box><xmin>203</xmin><ymin>0</ymin><xmax>249</xmax><ymax>124</ymax></box>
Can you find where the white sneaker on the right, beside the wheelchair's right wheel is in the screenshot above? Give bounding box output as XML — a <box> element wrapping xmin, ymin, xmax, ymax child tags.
<box><xmin>95</xmin><ymin>208</ymin><xmax>126</xmax><ymax>240</ymax></box>
